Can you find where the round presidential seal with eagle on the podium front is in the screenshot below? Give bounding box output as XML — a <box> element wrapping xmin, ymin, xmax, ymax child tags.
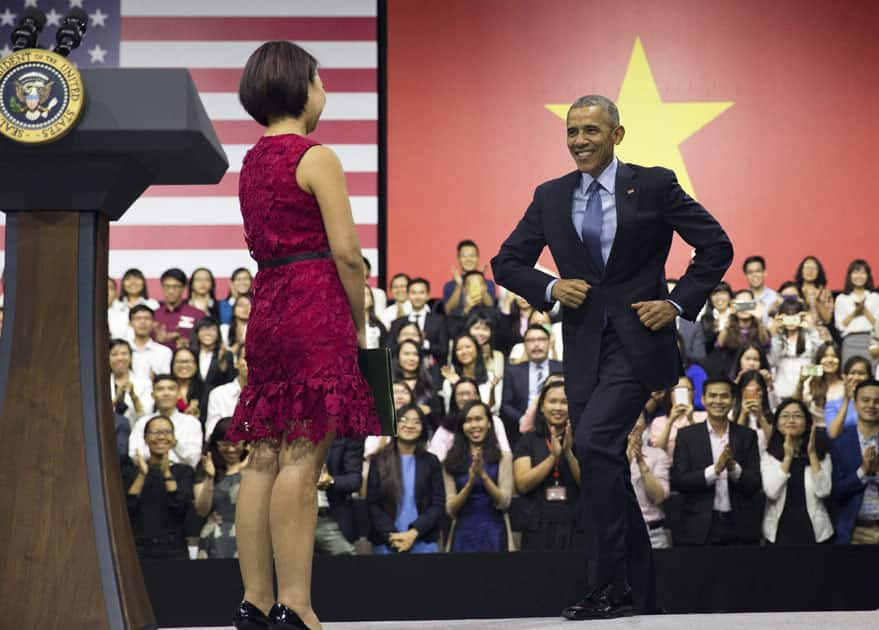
<box><xmin>0</xmin><ymin>48</ymin><xmax>85</xmax><ymax>144</ymax></box>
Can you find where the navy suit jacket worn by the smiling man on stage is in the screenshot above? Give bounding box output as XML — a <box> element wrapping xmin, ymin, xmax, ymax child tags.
<box><xmin>491</xmin><ymin>162</ymin><xmax>733</xmax><ymax>404</ymax></box>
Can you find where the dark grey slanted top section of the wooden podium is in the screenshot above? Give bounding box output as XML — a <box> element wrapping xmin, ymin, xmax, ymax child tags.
<box><xmin>0</xmin><ymin>68</ymin><xmax>229</xmax><ymax>219</ymax></box>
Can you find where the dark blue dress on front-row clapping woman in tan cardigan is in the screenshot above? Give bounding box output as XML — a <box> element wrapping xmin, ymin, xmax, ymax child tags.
<box><xmin>451</xmin><ymin>456</ymin><xmax>507</xmax><ymax>552</ymax></box>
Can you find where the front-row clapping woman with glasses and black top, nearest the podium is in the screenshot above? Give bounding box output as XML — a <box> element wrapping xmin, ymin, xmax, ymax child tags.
<box><xmin>122</xmin><ymin>415</ymin><xmax>192</xmax><ymax>559</ymax></box>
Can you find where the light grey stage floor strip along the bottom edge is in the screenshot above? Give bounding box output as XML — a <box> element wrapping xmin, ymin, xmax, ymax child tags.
<box><xmin>167</xmin><ymin>611</ymin><xmax>879</xmax><ymax>630</ymax></box>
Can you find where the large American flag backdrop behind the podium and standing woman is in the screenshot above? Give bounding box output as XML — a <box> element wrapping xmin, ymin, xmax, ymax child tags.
<box><xmin>0</xmin><ymin>0</ymin><xmax>379</xmax><ymax>297</ymax></box>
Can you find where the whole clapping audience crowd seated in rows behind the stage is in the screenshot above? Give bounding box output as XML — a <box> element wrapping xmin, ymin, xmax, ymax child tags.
<box><xmin>108</xmin><ymin>241</ymin><xmax>879</xmax><ymax>558</ymax></box>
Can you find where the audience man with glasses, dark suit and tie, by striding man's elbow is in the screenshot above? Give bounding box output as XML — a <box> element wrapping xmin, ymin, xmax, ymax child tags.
<box><xmin>501</xmin><ymin>324</ymin><xmax>562</xmax><ymax>448</ymax></box>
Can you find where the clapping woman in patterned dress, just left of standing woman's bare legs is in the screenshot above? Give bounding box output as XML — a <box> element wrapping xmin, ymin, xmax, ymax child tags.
<box><xmin>194</xmin><ymin>418</ymin><xmax>246</xmax><ymax>559</ymax></box>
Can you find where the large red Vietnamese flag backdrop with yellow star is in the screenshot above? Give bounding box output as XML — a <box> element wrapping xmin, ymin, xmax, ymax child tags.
<box><xmin>386</xmin><ymin>0</ymin><xmax>879</xmax><ymax>295</ymax></box>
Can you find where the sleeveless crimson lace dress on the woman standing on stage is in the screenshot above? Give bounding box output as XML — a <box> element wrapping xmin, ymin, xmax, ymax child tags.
<box><xmin>227</xmin><ymin>134</ymin><xmax>380</xmax><ymax>443</ymax></box>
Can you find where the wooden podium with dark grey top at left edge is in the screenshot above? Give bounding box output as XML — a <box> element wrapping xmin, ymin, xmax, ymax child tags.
<box><xmin>0</xmin><ymin>69</ymin><xmax>228</xmax><ymax>630</ymax></box>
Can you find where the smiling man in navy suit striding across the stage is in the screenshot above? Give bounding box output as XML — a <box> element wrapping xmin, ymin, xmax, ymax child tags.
<box><xmin>492</xmin><ymin>95</ymin><xmax>732</xmax><ymax>619</ymax></box>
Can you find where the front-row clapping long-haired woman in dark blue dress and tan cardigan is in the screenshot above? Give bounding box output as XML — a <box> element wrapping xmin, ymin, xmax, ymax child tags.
<box><xmin>443</xmin><ymin>400</ymin><xmax>513</xmax><ymax>552</ymax></box>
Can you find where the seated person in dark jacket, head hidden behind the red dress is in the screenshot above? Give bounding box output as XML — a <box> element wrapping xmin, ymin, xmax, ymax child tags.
<box><xmin>314</xmin><ymin>438</ymin><xmax>363</xmax><ymax>556</ymax></box>
